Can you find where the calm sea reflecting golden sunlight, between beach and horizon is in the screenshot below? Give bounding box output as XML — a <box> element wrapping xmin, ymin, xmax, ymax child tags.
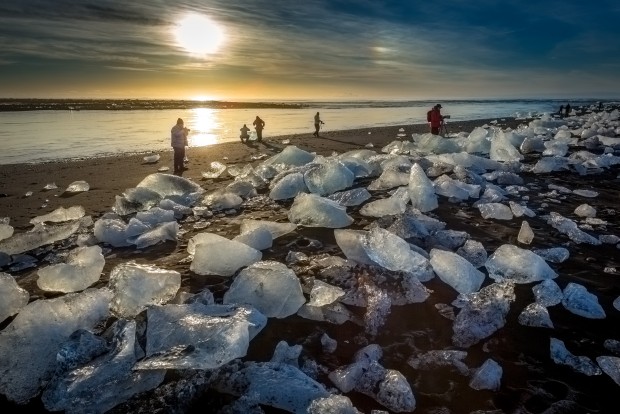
<box><xmin>0</xmin><ymin>99</ymin><xmax>597</xmax><ymax>164</ymax></box>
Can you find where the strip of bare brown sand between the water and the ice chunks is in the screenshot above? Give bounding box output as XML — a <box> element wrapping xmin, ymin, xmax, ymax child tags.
<box><xmin>0</xmin><ymin>118</ymin><xmax>525</xmax><ymax>228</ymax></box>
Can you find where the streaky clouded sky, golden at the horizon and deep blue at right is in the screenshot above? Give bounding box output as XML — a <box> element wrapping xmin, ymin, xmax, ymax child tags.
<box><xmin>0</xmin><ymin>0</ymin><xmax>620</xmax><ymax>101</ymax></box>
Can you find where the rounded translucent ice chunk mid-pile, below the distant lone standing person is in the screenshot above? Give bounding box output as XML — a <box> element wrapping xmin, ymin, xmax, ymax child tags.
<box><xmin>304</xmin><ymin>160</ymin><xmax>355</xmax><ymax>196</ymax></box>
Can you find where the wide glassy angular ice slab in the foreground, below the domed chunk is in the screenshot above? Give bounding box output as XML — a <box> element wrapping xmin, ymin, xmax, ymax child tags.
<box><xmin>136</xmin><ymin>302</ymin><xmax>267</xmax><ymax>369</ymax></box>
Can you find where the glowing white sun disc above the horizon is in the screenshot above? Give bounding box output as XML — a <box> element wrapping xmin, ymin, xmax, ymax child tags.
<box><xmin>174</xmin><ymin>13</ymin><xmax>224</xmax><ymax>56</ymax></box>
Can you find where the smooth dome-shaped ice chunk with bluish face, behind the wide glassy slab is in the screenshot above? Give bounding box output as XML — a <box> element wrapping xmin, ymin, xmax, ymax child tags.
<box><xmin>223</xmin><ymin>261</ymin><xmax>306</xmax><ymax>318</ymax></box>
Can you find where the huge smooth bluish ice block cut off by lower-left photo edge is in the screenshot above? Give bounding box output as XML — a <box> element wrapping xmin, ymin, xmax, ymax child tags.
<box><xmin>0</xmin><ymin>288</ymin><xmax>112</xmax><ymax>404</ymax></box>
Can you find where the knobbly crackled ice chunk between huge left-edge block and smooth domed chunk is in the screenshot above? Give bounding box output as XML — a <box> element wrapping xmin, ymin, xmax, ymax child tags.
<box><xmin>108</xmin><ymin>262</ymin><xmax>181</xmax><ymax>318</ymax></box>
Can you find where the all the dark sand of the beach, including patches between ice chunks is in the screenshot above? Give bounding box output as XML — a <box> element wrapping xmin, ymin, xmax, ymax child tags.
<box><xmin>0</xmin><ymin>118</ymin><xmax>620</xmax><ymax>413</ymax></box>
